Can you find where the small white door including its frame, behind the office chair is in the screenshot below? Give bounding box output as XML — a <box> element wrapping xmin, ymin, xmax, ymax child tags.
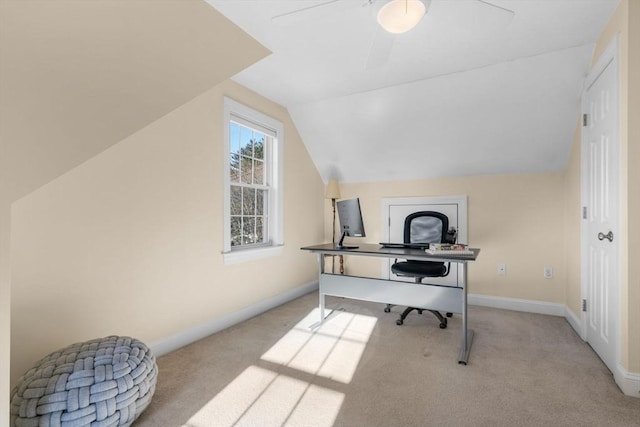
<box><xmin>382</xmin><ymin>196</ymin><xmax>467</xmax><ymax>286</ymax></box>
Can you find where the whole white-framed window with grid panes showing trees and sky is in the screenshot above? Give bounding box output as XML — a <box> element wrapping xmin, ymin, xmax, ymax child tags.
<box><xmin>223</xmin><ymin>98</ymin><xmax>284</xmax><ymax>262</ymax></box>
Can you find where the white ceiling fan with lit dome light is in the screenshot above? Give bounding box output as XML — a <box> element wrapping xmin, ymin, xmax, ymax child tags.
<box><xmin>271</xmin><ymin>0</ymin><xmax>514</xmax><ymax>69</ymax></box>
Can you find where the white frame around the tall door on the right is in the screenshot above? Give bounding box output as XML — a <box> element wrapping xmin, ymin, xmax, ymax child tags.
<box><xmin>580</xmin><ymin>35</ymin><xmax>622</xmax><ymax>366</ymax></box>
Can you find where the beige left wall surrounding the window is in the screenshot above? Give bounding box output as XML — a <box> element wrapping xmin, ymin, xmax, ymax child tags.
<box><xmin>11</xmin><ymin>81</ymin><xmax>323</xmax><ymax>383</ymax></box>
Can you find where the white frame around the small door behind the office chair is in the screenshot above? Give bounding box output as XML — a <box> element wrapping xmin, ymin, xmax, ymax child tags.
<box><xmin>380</xmin><ymin>195</ymin><xmax>469</xmax><ymax>280</ymax></box>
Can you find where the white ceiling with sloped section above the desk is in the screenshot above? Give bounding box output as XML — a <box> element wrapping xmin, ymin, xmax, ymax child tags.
<box><xmin>207</xmin><ymin>0</ymin><xmax>618</xmax><ymax>182</ymax></box>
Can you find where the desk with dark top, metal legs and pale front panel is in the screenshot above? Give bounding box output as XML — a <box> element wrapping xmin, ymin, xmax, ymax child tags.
<box><xmin>301</xmin><ymin>243</ymin><xmax>480</xmax><ymax>365</ymax></box>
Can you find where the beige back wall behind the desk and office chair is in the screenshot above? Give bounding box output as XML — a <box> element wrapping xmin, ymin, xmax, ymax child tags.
<box><xmin>332</xmin><ymin>173</ymin><xmax>566</xmax><ymax>303</ymax></box>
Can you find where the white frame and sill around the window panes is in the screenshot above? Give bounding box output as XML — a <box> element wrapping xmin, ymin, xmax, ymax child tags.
<box><xmin>222</xmin><ymin>97</ymin><xmax>284</xmax><ymax>264</ymax></box>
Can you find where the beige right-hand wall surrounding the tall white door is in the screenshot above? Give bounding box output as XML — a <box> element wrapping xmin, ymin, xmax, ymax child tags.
<box><xmin>565</xmin><ymin>0</ymin><xmax>640</xmax><ymax>373</ymax></box>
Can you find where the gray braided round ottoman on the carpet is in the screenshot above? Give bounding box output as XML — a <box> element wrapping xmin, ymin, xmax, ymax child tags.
<box><xmin>11</xmin><ymin>336</ymin><xmax>158</xmax><ymax>427</ymax></box>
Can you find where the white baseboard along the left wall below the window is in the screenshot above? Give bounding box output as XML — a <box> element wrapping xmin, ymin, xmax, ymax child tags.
<box><xmin>149</xmin><ymin>280</ymin><xmax>318</xmax><ymax>356</ymax></box>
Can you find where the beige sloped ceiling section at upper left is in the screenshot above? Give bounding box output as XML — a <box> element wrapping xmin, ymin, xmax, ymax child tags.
<box><xmin>0</xmin><ymin>0</ymin><xmax>269</xmax><ymax>200</ymax></box>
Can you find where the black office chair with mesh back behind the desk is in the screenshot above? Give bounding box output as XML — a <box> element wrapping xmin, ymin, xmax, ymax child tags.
<box><xmin>385</xmin><ymin>211</ymin><xmax>457</xmax><ymax>329</ymax></box>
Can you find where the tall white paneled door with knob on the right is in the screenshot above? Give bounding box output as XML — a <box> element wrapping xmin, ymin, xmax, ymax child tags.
<box><xmin>582</xmin><ymin>40</ymin><xmax>620</xmax><ymax>372</ymax></box>
